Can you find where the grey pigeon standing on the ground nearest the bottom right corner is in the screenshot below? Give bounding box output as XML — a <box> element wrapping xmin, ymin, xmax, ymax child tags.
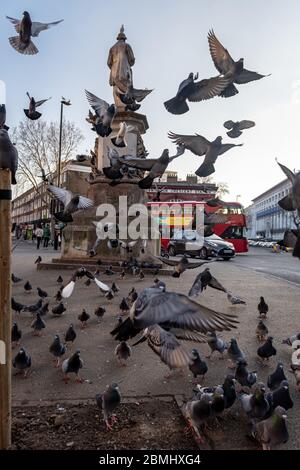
<box><xmin>252</xmin><ymin>406</ymin><xmax>289</xmax><ymax>450</ymax></box>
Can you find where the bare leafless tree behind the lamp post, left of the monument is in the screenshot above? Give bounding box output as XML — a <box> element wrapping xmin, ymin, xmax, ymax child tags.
<box><xmin>12</xmin><ymin>119</ymin><xmax>84</xmax><ymax>200</ymax></box>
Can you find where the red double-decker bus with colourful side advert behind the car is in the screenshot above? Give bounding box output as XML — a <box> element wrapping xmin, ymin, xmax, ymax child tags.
<box><xmin>147</xmin><ymin>201</ymin><xmax>248</xmax><ymax>253</ymax></box>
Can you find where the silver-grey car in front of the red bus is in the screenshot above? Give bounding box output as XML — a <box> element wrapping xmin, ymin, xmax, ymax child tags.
<box><xmin>168</xmin><ymin>230</ymin><xmax>235</xmax><ymax>261</ymax></box>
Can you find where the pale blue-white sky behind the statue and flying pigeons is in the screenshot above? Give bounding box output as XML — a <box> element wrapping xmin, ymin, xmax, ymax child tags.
<box><xmin>0</xmin><ymin>0</ymin><xmax>300</xmax><ymax>205</ymax></box>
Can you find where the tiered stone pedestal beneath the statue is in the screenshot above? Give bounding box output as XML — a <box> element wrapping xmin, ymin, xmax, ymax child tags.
<box><xmin>62</xmin><ymin>111</ymin><xmax>160</xmax><ymax>264</ymax></box>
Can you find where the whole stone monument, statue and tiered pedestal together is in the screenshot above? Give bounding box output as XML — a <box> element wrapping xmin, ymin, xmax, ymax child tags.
<box><xmin>61</xmin><ymin>26</ymin><xmax>160</xmax><ymax>263</ymax></box>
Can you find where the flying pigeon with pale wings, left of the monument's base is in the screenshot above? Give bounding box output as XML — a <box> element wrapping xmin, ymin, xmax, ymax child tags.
<box><xmin>47</xmin><ymin>185</ymin><xmax>94</xmax><ymax>223</ymax></box>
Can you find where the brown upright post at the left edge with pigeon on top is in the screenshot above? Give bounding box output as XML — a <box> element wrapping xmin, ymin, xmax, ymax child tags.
<box><xmin>0</xmin><ymin>169</ymin><xmax>11</xmax><ymax>449</ymax></box>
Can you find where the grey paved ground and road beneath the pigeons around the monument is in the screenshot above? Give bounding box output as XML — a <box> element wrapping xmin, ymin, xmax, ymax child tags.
<box><xmin>13</xmin><ymin>242</ymin><xmax>300</xmax><ymax>449</ymax></box>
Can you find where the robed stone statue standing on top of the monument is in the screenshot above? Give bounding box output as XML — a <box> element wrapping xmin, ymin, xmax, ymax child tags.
<box><xmin>107</xmin><ymin>25</ymin><xmax>135</xmax><ymax>111</ymax></box>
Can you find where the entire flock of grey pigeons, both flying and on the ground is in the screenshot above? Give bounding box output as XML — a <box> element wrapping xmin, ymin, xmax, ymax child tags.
<box><xmin>0</xmin><ymin>12</ymin><xmax>300</xmax><ymax>449</ymax></box>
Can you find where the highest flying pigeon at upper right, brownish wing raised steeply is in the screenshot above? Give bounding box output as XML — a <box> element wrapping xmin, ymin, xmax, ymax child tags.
<box><xmin>208</xmin><ymin>30</ymin><xmax>268</xmax><ymax>98</ymax></box>
